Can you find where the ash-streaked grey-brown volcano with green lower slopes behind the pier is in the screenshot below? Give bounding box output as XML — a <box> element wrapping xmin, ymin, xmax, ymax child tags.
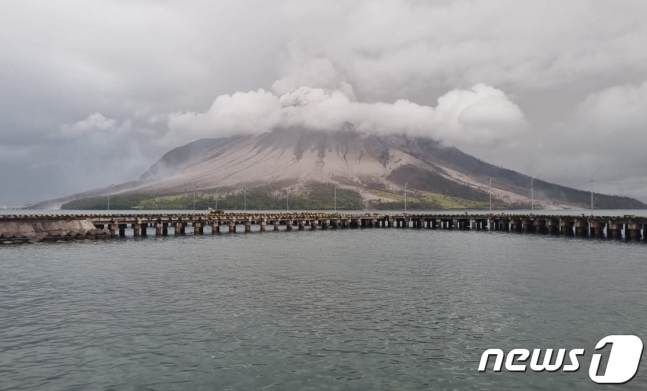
<box><xmin>35</xmin><ymin>126</ymin><xmax>646</xmax><ymax>209</ymax></box>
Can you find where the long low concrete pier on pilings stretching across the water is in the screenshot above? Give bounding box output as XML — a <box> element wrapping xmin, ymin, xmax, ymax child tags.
<box><xmin>0</xmin><ymin>213</ymin><xmax>647</xmax><ymax>244</ymax></box>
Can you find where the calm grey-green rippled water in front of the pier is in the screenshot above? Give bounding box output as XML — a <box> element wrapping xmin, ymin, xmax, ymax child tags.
<box><xmin>0</xmin><ymin>212</ymin><xmax>647</xmax><ymax>390</ymax></box>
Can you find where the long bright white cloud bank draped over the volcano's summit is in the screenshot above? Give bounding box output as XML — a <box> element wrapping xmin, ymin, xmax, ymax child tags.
<box><xmin>167</xmin><ymin>84</ymin><xmax>527</xmax><ymax>150</ymax></box>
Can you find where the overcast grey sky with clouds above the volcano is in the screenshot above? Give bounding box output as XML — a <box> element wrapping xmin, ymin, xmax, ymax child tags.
<box><xmin>0</xmin><ymin>0</ymin><xmax>647</xmax><ymax>205</ymax></box>
